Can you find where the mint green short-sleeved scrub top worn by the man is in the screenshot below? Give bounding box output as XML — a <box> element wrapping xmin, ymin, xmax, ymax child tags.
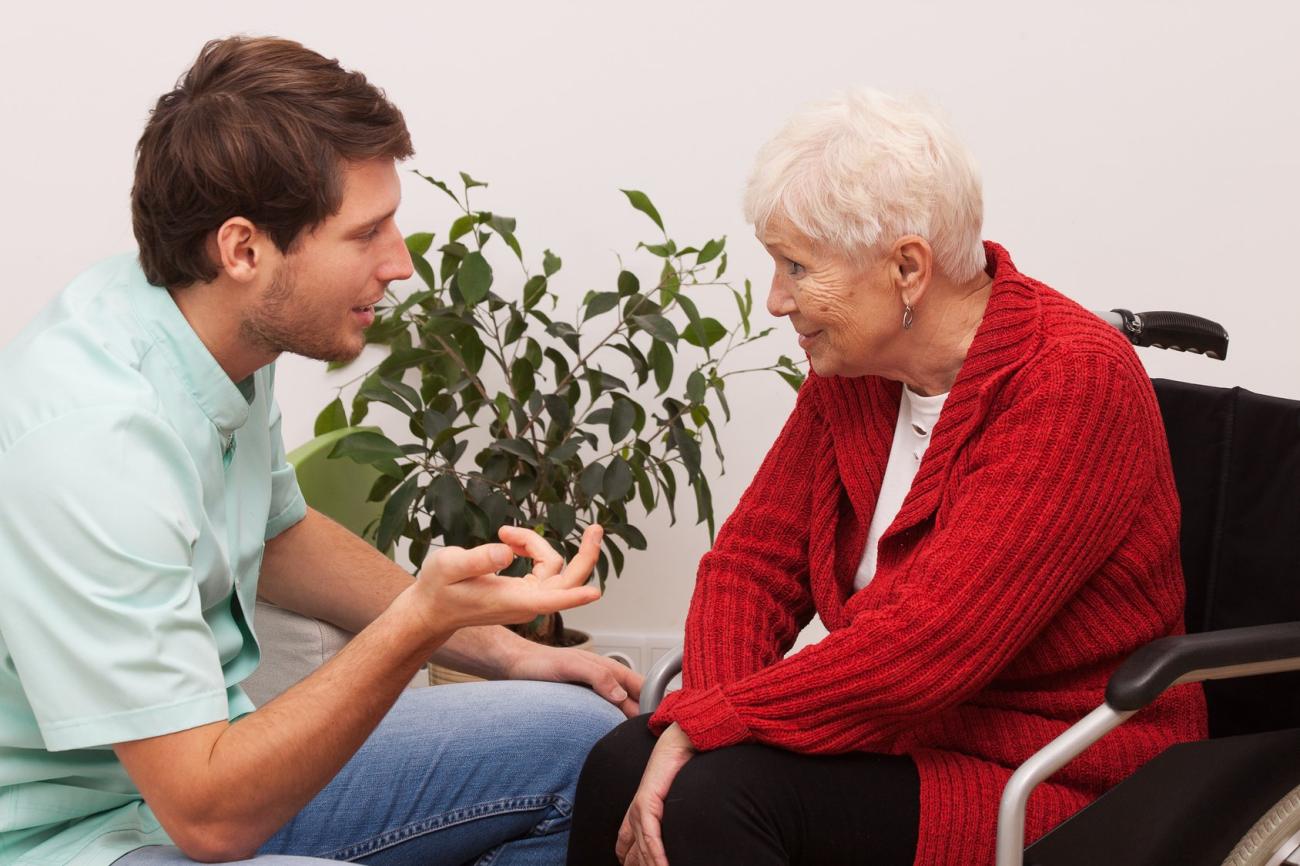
<box><xmin>0</xmin><ymin>256</ymin><xmax>306</xmax><ymax>866</ymax></box>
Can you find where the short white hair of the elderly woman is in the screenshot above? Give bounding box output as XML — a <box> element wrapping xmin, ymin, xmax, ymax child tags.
<box><xmin>745</xmin><ymin>88</ymin><xmax>984</xmax><ymax>281</ymax></box>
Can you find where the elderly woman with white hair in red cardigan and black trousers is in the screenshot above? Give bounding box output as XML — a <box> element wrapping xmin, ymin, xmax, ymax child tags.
<box><xmin>569</xmin><ymin>92</ymin><xmax>1205</xmax><ymax>866</ymax></box>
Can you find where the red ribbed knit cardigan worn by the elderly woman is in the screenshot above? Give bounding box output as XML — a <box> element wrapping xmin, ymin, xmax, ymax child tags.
<box><xmin>650</xmin><ymin>243</ymin><xmax>1206</xmax><ymax>866</ymax></box>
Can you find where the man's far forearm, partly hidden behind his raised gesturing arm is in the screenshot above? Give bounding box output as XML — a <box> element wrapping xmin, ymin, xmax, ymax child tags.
<box><xmin>257</xmin><ymin>508</ymin><xmax>530</xmax><ymax>679</ymax></box>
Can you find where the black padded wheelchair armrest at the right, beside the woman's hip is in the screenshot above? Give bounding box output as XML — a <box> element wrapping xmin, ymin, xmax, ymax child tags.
<box><xmin>1106</xmin><ymin>623</ymin><xmax>1300</xmax><ymax>711</ymax></box>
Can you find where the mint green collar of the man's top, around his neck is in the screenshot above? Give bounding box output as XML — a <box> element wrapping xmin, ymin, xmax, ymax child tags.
<box><xmin>131</xmin><ymin>270</ymin><xmax>257</xmax><ymax>441</ymax></box>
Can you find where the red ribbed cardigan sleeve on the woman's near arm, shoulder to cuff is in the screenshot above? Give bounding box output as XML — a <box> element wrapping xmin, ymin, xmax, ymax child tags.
<box><xmin>651</xmin><ymin>352</ymin><xmax>1160</xmax><ymax>753</ymax></box>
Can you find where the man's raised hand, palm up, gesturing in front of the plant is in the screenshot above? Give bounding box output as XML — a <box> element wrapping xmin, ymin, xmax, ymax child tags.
<box><xmin>404</xmin><ymin>524</ymin><xmax>603</xmax><ymax>635</ymax></box>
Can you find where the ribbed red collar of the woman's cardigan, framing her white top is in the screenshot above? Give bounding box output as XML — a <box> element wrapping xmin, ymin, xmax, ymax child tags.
<box><xmin>819</xmin><ymin>241</ymin><xmax>1039</xmax><ymax>541</ymax></box>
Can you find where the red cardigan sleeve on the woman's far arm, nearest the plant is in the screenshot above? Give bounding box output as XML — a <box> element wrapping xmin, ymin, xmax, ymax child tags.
<box><xmin>665</xmin><ymin>381</ymin><xmax>826</xmax><ymax>689</ymax></box>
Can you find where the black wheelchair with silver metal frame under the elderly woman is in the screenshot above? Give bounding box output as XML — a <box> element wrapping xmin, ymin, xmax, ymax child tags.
<box><xmin>641</xmin><ymin>309</ymin><xmax>1300</xmax><ymax>866</ymax></box>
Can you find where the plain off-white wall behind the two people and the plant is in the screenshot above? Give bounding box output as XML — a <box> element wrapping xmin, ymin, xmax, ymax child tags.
<box><xmin>0</xmin><ymin>0</ymin><xmax>1300</xmax><ymax>632</ymax></box>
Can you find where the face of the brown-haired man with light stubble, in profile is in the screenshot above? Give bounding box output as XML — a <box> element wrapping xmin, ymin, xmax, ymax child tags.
<box><xmin>239</xmin><ymin>160</ymin><xmax>412</xmax><ymax>360</ymax></box>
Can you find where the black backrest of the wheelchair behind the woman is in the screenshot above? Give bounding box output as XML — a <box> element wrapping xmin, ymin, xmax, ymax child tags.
<box><xmin>1154</xmin><ymin>380</ymin><xmax>1300</xmax><ymax>737</ymax></box>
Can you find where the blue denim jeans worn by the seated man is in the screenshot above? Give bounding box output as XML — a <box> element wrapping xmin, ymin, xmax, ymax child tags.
<box><xmin>114</xmin><ymin>681</ymin><xmax>624</xmax><ymax>866</ymax></box>
